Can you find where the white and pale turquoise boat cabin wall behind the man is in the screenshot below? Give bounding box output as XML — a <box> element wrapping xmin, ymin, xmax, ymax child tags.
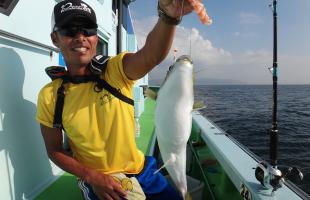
<box><xmin>0</xmin><ymin>0</ymin><xmax>146</xmax><ymax>200</ymax></box>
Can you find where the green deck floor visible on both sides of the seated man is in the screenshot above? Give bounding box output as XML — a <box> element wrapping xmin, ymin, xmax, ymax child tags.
<box><xmin>35</xmin><ymin>99</ymin><xmax>155</xmax><ymax>200</ymax></box>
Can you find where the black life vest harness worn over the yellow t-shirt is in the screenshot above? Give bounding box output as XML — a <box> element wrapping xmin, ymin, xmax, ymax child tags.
<box><xmin>45</xmin><ymin>55</ymin><xmax>134</xmax><ymax>129</ymax></box>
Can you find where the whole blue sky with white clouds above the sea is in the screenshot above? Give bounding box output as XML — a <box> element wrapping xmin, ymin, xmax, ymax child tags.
<box><xmin>130</xmin><ymin>0</ymin><xmax>310</xmax><ymax>84</ymax></box>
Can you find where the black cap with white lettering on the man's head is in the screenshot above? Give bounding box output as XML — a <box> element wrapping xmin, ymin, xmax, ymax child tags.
<box><xmin>52</xmin><ymin>0</ymin><xmax>98</xmax><ymax>32</ymax></box>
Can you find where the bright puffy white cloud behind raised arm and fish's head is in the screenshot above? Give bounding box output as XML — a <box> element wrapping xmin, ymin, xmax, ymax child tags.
<box><xmin>133</xmin><ymin>17</ymin><xmax>231</xmax><ymax>78</ymax></box>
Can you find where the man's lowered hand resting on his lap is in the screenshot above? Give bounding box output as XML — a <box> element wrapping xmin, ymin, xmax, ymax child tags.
<box><xmin>89</xmin><ymin>171</ymin><xmax>127</xmax><ymax>200</ymax></box>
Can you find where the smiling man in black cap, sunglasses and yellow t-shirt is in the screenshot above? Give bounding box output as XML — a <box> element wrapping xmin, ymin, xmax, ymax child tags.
<box><xmin>36</xmin><ymin>0</ymin><xmax>192</xmax><ymax>200</ymax></box>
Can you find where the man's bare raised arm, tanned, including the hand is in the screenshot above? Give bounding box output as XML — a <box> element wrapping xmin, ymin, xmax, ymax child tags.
<box><xmin>123</xmin><ymin>0</ymin><xmax>192</xmax><ymax>80</ymax></box>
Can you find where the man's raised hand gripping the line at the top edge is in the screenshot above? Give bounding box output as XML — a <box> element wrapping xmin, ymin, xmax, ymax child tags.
<box><xmin>159</xmin><ymin>0</ymin><xmax>195</xmax><ymax>18</ymax></box>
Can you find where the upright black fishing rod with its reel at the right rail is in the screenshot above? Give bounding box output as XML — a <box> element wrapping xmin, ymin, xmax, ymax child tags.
<box><xmin>255</xmin><ymin>0</ymin><xmax>303</xmax><ymax>194</ymax></box>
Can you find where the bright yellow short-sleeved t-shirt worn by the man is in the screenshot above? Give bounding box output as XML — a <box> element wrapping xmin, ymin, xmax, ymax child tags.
<box><xmin>36</xmin><ymin>53</ymin><xmax>144</xmax><ymax>174</ymax></box>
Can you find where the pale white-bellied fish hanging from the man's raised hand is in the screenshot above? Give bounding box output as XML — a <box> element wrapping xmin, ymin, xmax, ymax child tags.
<box><xmin>146</xmin><ymin>55</ymin><xmax>199</xmax><ymax>199</ymax></box>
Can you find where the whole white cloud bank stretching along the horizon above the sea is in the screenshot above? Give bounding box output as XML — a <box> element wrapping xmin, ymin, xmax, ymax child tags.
<box><xmin>133</xmin><ymin>15</ymin><xmax>310</xmax><ymax>84</ymax></box>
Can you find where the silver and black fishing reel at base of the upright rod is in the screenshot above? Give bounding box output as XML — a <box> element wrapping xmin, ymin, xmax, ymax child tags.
<box><xmin>255</xmin><ymin>161</ymin><xmax>303</xmax><ymax>194</ymax></box>
